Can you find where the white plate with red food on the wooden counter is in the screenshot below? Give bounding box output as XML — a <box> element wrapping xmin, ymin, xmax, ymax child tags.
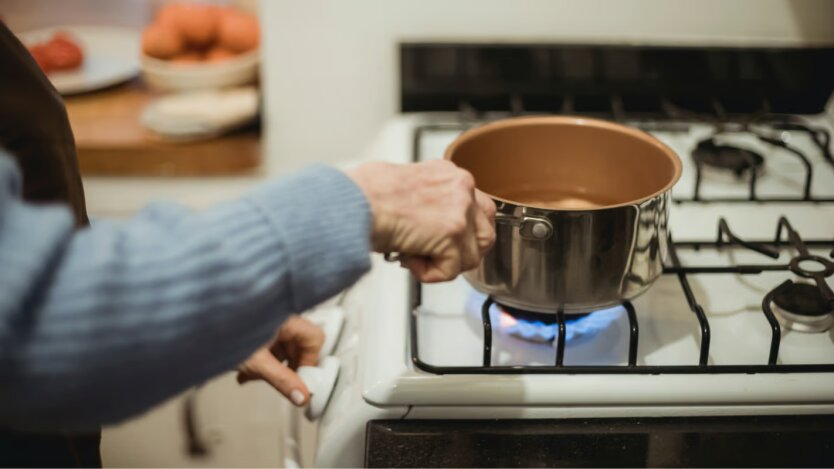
<box><xmin>19</xmin><ymin>26</ymin><xmax>141</xmax><ymax>95</ymax></box>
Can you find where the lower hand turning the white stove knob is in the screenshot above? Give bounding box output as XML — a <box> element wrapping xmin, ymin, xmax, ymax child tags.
<box><xmin>237</xmin><ymin>316</ymin><xmax>324</xmax><ymax>406</ymax></box>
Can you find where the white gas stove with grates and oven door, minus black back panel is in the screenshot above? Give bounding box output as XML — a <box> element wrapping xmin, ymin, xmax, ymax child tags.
<box><xmin>292</xmin><ymin>42</ymin><xmax>834</xmax><ymax>466</ymax></box>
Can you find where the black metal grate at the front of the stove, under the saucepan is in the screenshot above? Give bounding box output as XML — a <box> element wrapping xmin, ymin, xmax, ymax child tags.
<box><xmin>410</xmin><ymin>217</ymin><xmax>834</xmax><ymax>374</ymax></box>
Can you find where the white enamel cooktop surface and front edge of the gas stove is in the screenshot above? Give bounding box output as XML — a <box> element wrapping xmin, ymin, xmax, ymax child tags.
<box><xmin>284</xmin><ymin>109</ymin><xmax>834</xmax><ymax>466</ymax></box>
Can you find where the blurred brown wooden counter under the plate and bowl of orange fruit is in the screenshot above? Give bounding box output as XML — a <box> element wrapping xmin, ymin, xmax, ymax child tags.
<box><xmin>65</xmin><ymin>80</ymin><xmax>261</xmax><ymax>176</ymax></box>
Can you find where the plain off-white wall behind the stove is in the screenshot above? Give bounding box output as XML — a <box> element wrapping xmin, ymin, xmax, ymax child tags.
<box><xmin>261</xmin><ymin>0</ymin><xmax>834</xmax><ymax>170</ymax></box>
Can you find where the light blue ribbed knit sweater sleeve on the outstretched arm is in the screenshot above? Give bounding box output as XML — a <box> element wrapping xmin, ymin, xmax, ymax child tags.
<box><xmin>0</xmin><ymin>153</ymin><xmax>371</xmax><ymax>430</ymax></box>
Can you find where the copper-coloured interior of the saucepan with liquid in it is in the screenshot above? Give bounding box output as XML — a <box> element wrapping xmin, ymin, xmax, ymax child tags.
<box><xmin>446</xmin><ymin>117</ymin><xmax>681</xmax><ymax>210</ymax></box>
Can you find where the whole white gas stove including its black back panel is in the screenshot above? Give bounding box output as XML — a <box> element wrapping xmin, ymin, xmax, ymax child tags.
<box><xmin>258</xmin><ymin>23</ymin><xmax>834</xmax><ymax>458</ymax></box>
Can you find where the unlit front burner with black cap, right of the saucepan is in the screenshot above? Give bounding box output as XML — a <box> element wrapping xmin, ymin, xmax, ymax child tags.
<box><xmin>773</xmin><ymin>283</ymin><xmax>834</xmax><ymax>332</ymax></box>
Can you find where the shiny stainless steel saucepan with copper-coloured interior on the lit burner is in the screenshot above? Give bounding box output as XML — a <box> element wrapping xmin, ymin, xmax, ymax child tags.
<box><xmin>446</xmin><ymin>116</ymin><xmax>681</xmax><ymax>313</ymax></box>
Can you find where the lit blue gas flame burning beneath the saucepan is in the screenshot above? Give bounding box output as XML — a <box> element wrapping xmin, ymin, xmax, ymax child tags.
<box><xmin>467</xmin><ymin>290</ymin><xmax>625</xmax><ymax>343</ymax></box>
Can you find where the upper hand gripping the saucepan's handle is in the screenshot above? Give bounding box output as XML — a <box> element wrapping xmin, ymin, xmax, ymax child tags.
<box><xmin>348</xmin><ymin>160</ymin><xmax>495</xmax><ymax>282</ymax></box>
